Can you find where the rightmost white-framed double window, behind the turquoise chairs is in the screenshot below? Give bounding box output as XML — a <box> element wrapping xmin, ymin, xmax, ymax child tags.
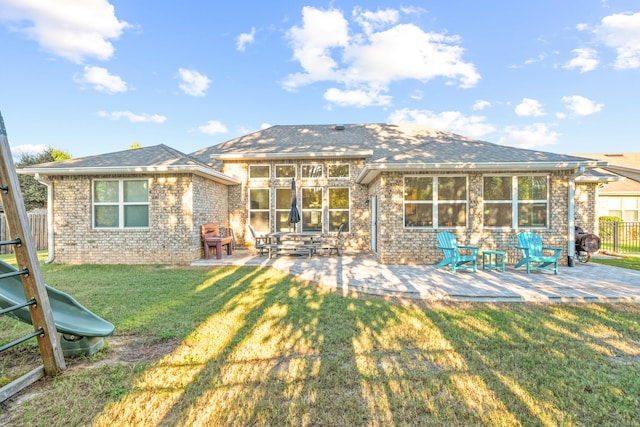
<box><xmin>483</xmin><ymin>176</ymin><xmax>549</xmax><ymax>228</ymax></box>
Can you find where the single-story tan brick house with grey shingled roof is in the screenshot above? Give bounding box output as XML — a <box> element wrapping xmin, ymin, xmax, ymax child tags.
<box><xmin>19</xmin><ymin>124</ymin><xmax>606</xmax><ymax>264</ymax></box>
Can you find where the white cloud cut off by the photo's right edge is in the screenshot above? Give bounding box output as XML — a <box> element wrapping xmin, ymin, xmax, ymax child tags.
<box><xmin>594</xmin><ymin>12</ymin><xmax>640</xmax><ymax>70</ymax></box>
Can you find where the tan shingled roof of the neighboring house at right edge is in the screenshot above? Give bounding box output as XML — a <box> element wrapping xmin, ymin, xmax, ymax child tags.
<box><xmin>576</xmin><ymin>153</ymin><xmax>640</xmax><ymax>195</ymax></box>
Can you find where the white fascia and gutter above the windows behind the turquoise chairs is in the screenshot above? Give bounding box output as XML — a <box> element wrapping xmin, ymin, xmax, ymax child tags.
<box><xmin>356</xmin><ymin>161</ymin><xmax>606</xmax><ymax>184</ymax></box>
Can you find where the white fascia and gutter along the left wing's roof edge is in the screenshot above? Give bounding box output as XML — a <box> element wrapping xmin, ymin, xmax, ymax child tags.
<box><xmin>16</xmin><ymin>165</ymin><xmax>242</xmax><ymax>185</ymax></box>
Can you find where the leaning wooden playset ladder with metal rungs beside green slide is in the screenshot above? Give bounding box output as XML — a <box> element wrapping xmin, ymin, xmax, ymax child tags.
<box><xmin>0</xmin><ymin>113</ymin><xmax>66</xmax><ymax>402</ymax></box>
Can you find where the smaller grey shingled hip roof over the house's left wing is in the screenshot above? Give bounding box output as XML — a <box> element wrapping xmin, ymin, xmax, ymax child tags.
<box><xmin>18</xmin><ymin>144</ymin><xmax>240</xmax><ymax>185</ymax></box>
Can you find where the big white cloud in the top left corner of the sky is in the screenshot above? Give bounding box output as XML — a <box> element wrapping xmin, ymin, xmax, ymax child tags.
<box><xmin>0</xmin><ymin>0</ymin><xmax>130</xmax><ymax>63</ymax></box>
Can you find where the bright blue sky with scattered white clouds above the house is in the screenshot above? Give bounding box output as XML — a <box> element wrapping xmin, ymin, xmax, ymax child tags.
<box><xmin>0</xmin><ymin>0</ymin><xmax>640</xmax><ymax>158</ymax></box>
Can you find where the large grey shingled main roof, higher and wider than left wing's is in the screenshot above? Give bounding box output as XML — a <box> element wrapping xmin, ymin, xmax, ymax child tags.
<box><xmin>192</xmin><ymin>123</ymin><xmax>606</xmax><ymax>184</ymax></box>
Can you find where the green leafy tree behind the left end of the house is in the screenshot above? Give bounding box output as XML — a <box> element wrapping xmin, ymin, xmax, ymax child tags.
<box><xmin>16</xmin><ymin>147</ymin><xmax>71</xmax><ymax>211</ymax></box>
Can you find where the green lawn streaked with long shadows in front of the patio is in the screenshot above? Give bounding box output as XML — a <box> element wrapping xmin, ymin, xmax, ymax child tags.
<box><xmin>0</xmin><ymin>256</ymin><xmax>640</xmax><ymax>427</ymax></box>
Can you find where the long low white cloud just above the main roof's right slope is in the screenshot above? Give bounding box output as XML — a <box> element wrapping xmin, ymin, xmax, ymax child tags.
<box><xmin>389</xmin><ymin>108</ymin><xmax>495</xmax><ymax>138</ymax></box>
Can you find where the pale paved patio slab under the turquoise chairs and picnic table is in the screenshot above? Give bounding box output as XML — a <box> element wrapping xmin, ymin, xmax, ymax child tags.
<box><xmin>191</xmin><ymin>250</ymin><xmax>640</xmax><ymax>303</ymax></box>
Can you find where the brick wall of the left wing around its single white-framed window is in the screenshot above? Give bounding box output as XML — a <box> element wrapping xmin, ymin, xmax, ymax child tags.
<box><xmin>51</xmin><ymin>174</ymin><xmax>227</xmax><ymax>264</ymax></box>
